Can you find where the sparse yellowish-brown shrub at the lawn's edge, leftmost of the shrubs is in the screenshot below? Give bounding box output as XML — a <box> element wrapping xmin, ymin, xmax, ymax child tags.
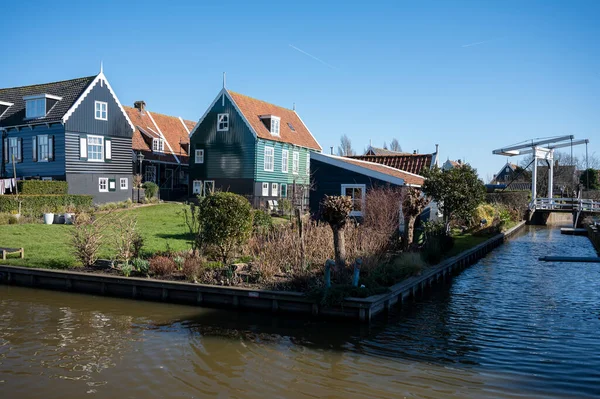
<box><xmin>71</xmin><ymin>213</ymin><xmax>110</xmax><ymax>267</ymax></box>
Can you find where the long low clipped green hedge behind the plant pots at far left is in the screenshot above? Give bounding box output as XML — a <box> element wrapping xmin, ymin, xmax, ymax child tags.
<box><xmin>0</xmin><ymin>194</ymin><xmax>92</xmax><ymax>216</ymax></box>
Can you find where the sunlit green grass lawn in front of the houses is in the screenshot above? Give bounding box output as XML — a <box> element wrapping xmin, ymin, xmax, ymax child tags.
<box><xmin>0</xmin><ymin>204</ymin><xmax>189</xmax><ymax>268</ymax></box>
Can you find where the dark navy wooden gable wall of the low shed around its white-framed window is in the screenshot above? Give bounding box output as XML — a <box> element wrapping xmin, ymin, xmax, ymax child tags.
<box><xmin>309</xmin><ymin>159</ymin><xmax>395</xmax><ymax>218</ymax></box>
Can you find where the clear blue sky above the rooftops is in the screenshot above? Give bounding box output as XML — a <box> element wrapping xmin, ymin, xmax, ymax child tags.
<box><xmin>0</xmin><ymin>0</ymin><xmax>600</xmax><ymax>178</ymax></box>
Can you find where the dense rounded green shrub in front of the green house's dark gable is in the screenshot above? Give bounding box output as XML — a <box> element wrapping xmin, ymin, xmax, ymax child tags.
<box><xmin>198</xmin><ymin>192</ymin><xmax>252</xmax><ymax>264</ymax></box>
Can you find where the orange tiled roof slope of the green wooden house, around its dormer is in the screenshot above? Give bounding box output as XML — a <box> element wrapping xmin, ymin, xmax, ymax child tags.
<box><xmin>228</xmin><ymin>91</ymin><xmax>321</xmax><ymax>151</ymax></box>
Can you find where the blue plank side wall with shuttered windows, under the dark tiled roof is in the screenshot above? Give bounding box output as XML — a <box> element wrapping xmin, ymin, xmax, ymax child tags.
<box><xmin>0</xmin><ymin>124</ymin><xmax>65</xmax><ymax>179</ymax></box>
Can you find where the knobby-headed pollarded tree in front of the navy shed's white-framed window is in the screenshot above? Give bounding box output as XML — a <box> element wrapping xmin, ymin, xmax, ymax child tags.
<box><xmin>321</xmin><ymin>195</ymin><xmax>352</xmax><ymax>270</ymax></box>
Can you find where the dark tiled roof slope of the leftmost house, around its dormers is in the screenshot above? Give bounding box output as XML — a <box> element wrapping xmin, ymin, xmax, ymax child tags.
<box><xmin>0</xmin><ymin>76</ymin><xmax>96</xmax><ymax>127</ymax></box>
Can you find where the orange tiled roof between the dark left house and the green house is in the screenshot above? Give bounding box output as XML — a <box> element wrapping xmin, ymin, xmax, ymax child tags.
<box><xmin>123</xmin><ymin>106</ymin><xmax>195</xmax><ymax>164</ymax></box>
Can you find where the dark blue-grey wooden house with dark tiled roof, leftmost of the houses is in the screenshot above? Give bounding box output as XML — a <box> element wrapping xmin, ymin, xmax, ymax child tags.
<box><xmin>0</xmin><ymin>72</ymin><xmax>134</xmax><ymax>203</ymax></box>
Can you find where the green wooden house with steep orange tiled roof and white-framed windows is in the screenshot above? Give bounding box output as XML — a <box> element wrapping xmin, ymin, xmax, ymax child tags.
<box><xmin>189</xmin><ymin>88</ymin><xmax>321</xmax><ymax>207</ymax></box>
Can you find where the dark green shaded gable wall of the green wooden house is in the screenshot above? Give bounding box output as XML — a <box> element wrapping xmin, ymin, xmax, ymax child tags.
<box><xmin>189</xmin><ymin>92</ymin><xmax>256</xmax><ymax>196</ymax></box>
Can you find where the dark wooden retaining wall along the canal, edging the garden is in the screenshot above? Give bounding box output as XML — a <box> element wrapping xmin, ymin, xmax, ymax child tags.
<box><xmin>0</xmin><ymin>222</ymin><xmax>525</xmax><ymax>322</ymax></box>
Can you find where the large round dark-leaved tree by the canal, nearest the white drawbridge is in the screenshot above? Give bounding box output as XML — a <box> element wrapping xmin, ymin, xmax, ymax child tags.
<box><xmin>423</xmin><ymin>164</ymin><xmax>485</xmax><ymax>232</ymax></box>
